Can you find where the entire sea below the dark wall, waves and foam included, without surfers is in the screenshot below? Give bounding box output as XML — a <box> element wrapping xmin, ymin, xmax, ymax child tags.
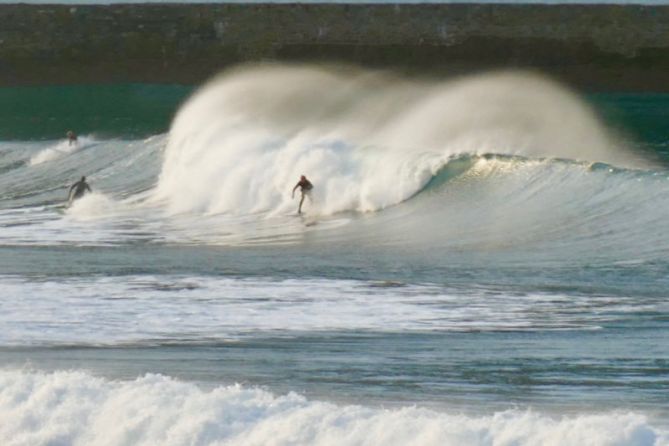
<box><xmin>0</xmin><ymin>65</ymin><xmax>669</xmax><ymax>446</ymax></box>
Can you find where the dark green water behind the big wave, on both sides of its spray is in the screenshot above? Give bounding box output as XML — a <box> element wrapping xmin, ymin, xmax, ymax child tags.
<box><xmin>5</xmin><ymin>84</ymin><xmax>669</xmax><ymax>159</ymax></box>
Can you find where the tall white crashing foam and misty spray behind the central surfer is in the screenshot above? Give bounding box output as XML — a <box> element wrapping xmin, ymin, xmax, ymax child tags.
<box><xmin>156</xmin><ymin>66</ymin><xmax>640</xmax><ymax>218</ymax></box>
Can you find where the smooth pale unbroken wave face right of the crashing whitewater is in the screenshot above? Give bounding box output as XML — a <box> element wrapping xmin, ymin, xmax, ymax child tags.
<box><xmin>358</xmin><ymin>155</ymin><xmax>669</xmax><ymax>262</ymax></box>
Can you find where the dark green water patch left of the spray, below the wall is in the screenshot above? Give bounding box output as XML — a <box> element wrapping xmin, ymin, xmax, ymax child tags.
<box><xmin>0</xmin><ymin>84</ymin><xmax>193</xmax><ymax>141</ymax></box>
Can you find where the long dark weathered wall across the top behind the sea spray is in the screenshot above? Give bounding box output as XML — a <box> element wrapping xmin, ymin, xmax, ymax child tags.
<box><xmin>0</xmin><ymin>4</ymin><xmax>669</xmax><ymax>91</ymax></box>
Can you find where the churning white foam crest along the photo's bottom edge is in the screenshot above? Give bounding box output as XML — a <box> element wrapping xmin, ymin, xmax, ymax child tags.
<box><xmin>0</xmin><ymin>370</ymin><xmax>669</xmax><ymax>446</ymax></box>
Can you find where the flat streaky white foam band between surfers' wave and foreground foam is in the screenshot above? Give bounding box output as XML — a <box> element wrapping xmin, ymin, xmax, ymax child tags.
<box><xmin>0</xmin><ymin>276</ymin><xmax>667</xmax><ymax>346</ymax></box>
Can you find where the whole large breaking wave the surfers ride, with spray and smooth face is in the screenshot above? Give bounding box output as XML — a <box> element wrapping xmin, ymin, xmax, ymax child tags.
<box><xmin>0</xmin><ymin>65</ymin><xmax>669</xmax><ymax>261</ymax></box>
